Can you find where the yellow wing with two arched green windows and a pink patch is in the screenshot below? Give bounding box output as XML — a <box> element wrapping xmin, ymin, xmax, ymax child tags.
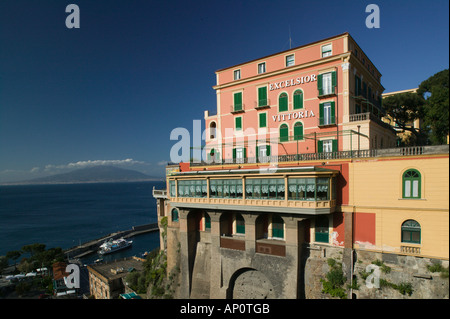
<box><xmin>343</xmin><ymin>146</ymin><xmax>449</xmax><ymax>260</ymax></box>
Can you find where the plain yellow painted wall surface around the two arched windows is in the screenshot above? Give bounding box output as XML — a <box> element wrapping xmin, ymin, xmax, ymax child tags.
<box><xmin>349</xmin><ymin>155</ymin><xmax>449</xmax><ymax>259</ymax></box>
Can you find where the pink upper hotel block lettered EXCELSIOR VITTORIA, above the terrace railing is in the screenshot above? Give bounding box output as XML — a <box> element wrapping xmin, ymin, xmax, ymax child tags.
<box><xmin>205</xmin><ymin>33</ymin><xmax>396</xmax><ymax>163</ymax></box>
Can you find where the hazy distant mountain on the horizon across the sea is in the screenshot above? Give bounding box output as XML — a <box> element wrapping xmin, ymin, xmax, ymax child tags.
<box><xmin>3</xmin><ymin>165</ymin><xmax>162</xmax><ymax>185</ymax></box>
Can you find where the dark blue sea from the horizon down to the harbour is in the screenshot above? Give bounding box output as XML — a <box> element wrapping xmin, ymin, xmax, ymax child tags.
<box><xmin>0</xmin><ymin>182</ymin><xmax>165</xmax><ymax>264</ymax></box>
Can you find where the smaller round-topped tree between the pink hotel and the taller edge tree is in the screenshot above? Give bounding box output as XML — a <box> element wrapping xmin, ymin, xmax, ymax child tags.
<box><xmin>383</xmin><ymin>92</ymin><xmax>426</xmax><ymax>145</ymax></box>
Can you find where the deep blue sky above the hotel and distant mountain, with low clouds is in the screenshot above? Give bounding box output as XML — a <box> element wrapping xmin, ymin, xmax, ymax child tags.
<box><xmin>0</xmin><ymin>0</ymin><xmax>449</xmax><ymax>182</ymax></box>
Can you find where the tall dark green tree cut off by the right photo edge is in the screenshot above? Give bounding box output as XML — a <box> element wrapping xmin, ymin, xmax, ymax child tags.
<box><xmin>417</xmin><ymin>69</ymin><xmax>449</xmax><ymax>145</ymax></box>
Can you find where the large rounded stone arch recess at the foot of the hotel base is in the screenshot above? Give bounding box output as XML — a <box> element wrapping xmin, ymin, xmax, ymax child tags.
<box><xmin>227</xmin><ymin>268</ymin><xmax>275</xmax><ymax>299</ymax></box>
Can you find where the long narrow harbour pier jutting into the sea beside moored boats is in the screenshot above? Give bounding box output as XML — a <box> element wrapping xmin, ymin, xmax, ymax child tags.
<box><xmin>64</xmin><ymin>223</ymin><xmax>159</xmax><ymax>259</ymax></box>
